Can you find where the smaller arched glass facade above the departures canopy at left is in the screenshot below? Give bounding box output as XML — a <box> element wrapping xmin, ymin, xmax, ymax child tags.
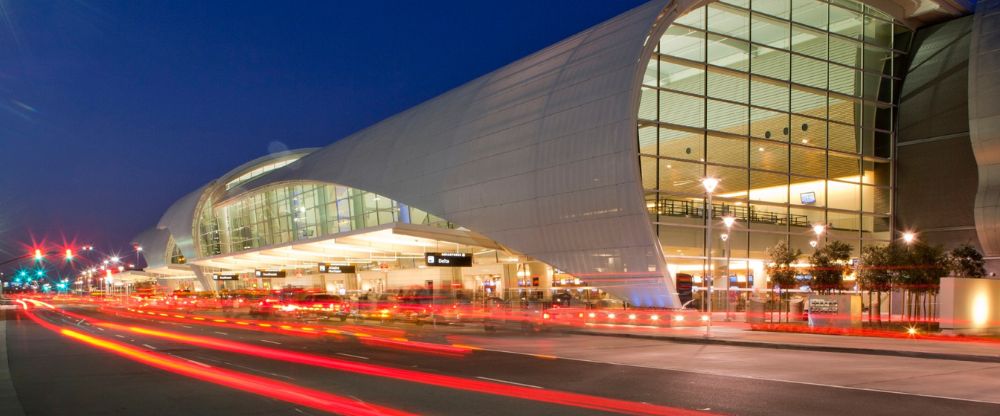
<box><xmin>195</xmin><ymin>182</ymin><xmax>454</xmax><ymax>257</ymax></box>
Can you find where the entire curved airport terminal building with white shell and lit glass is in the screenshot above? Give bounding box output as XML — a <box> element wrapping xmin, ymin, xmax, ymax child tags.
<box><xmin>136</xmin><ymin>0</ymin><xmax>1000</xmax><ymax>307</ymax></box>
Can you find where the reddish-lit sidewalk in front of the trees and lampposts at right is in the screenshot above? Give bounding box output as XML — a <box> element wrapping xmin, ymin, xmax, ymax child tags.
<box><xmin>569</xmin><ymin>322</ymin><xmax>1000</xmax><ymax>363</ymax></box>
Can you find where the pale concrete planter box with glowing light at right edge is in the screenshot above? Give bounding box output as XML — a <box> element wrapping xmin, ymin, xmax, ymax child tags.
<box><xmin>938</xmin><ymin>277</ymin><xmax>1000</xmax><ymax>334</ymax></box>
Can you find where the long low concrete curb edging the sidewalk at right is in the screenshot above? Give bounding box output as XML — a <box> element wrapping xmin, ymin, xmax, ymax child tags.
<box><xmin>567</xmin><ymin>331</ymin><xmax>1000</xmax><ymax>363</ymax></box>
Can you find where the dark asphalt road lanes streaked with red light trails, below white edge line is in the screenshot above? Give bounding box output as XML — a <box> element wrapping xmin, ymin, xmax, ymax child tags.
<box><xmin>7</xmin><ymin>309</ymin><xmax>1000</xmax><ymax>416</ymax></box>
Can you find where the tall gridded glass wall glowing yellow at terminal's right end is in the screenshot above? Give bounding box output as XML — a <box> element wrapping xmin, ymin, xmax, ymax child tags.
<box><xmin>638</xmin><ymin>0</ymin><xmax>909</xmax><ymax>279</ymax></box>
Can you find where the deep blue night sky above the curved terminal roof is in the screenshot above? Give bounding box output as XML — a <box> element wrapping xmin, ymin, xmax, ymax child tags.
<box><xmin>0</xmin><ymin>0</ymin><xmax>643</xmax><ymax>260</ymax></box>
